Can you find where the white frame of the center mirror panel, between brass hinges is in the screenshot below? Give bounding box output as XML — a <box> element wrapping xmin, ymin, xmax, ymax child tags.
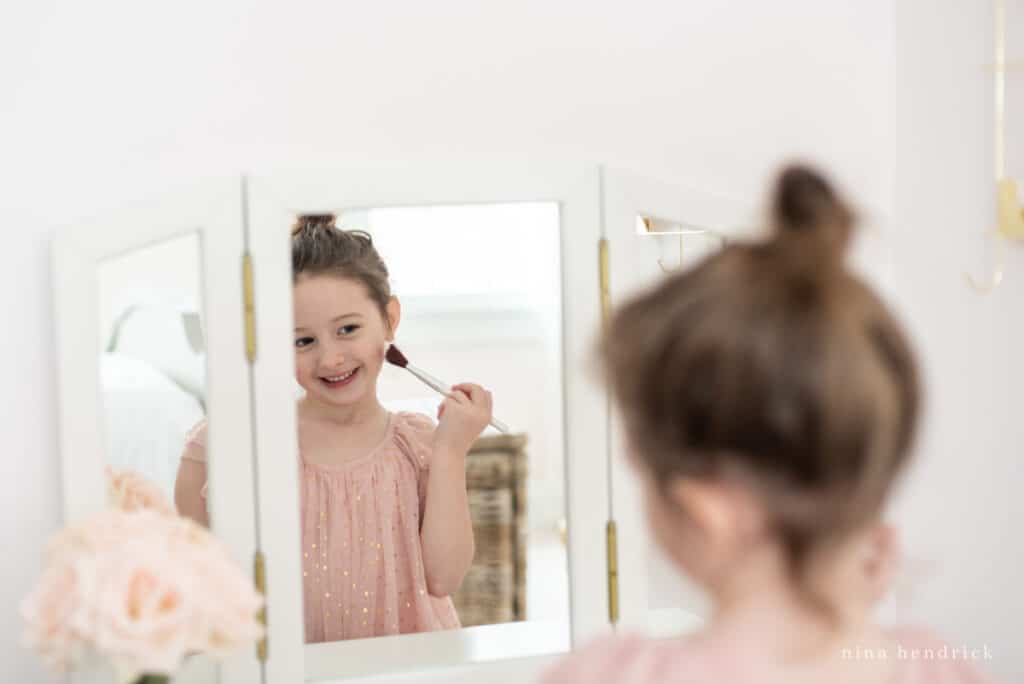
<box><xmin>249</xmin><ymin>163</ymin><xmax>610</xmax><ymax>684</ymax></box>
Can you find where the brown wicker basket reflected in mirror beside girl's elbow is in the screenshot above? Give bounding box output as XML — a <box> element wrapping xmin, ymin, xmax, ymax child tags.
<box><xmin>452</xmin><ymin>434</ymin><xmax>526</xmax><ymax>627</ymax></box>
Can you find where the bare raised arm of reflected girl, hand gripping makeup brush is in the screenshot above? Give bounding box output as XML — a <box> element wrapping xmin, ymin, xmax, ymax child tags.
<box><xmin>420</xmin><ymin>383</ymin><xmax>492</xmax><ymax>596</ymax></box>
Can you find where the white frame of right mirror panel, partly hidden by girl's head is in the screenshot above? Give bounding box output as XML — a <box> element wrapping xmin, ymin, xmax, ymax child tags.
<box><xmin>602</xmin><ymin>169</ymin><xmax>748</xmax><ymax>637</ymax></box>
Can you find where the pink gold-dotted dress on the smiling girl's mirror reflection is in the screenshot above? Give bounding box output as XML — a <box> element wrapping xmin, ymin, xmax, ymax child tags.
<box><xmin>188</xmin><ymin>413</ymin><xmax>460</xmax><ymax>643</ymax></box>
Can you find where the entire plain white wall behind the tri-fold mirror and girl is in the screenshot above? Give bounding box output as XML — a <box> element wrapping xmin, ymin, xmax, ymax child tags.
<box><xmin>0</xmin><ymin>0</ymin><xmax>1024</xmax><ymax>682</ymax></box>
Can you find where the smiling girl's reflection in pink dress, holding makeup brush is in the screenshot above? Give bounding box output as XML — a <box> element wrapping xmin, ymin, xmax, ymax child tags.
<box><xmin>175</xmin><ymin>215</ymin><xmax>492</xmax><ymax>642</ymax></box>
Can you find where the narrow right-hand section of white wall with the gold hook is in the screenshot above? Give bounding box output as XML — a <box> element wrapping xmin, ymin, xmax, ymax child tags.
<box><xmin>887</xmin><ymin>0</ymin><xmax>1024</xmax><ymax>682</ymax></box>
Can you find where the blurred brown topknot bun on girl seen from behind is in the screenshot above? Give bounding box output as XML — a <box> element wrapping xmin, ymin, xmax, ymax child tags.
<box><xmin>771</xmin><ymin>165</ymin><xmax>856</xmax><ymax>263</ymax></box>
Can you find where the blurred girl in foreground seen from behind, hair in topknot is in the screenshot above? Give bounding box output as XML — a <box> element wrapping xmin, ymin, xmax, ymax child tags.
<box><xmin>545</xmin><ymin>168</ymin><xmax>987</xmax><ymax>684</ymax></box>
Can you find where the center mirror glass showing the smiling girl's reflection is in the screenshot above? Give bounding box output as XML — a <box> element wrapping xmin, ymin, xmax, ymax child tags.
<box><xmin>292</xmin><ymin>202</ymin><xmax>569</xmax><ymax>657</ymax></box>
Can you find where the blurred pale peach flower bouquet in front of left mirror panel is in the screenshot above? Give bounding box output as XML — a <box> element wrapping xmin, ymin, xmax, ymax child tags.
<box><xmin>22</xmin><ymin>471</ymin><xmax>263</xmax><ymax>684</ymax></box>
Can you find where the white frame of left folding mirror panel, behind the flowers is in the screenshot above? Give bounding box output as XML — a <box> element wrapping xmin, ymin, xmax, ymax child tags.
<box><xmin>52</xmin><ymin>179</ymin><xmax>261</xmax><ymax>684</ymax></box>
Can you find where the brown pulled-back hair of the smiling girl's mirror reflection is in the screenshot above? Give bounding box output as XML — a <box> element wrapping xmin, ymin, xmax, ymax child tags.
<box><xmin>292</xmin><ymin>214</ymin><xmax>391</xmax><ymax>325</ymax></box>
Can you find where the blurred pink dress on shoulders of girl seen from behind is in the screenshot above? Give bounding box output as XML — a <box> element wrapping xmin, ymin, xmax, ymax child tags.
<box><xmin>541</xmin><ymin>627</ymin><xmax>991</xmax><ymax>684</ymax></box>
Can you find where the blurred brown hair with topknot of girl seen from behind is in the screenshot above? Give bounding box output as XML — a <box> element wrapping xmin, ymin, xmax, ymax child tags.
<box><xmin>599</xmin><ymin>167</ymin><xmax>919</xmax><ymax>604</ymax></box>
